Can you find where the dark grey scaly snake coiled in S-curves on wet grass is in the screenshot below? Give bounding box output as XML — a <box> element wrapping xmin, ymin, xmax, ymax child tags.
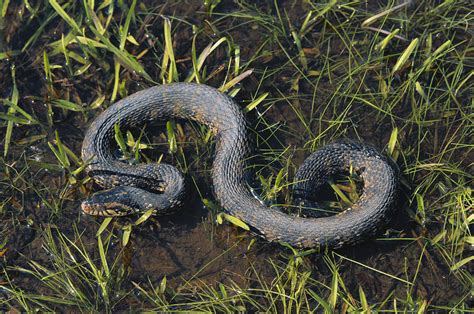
<box><xmin>82</xmin><ymin>83</ymin><xmax>397</xmax><ymax>248</ymax></box>
